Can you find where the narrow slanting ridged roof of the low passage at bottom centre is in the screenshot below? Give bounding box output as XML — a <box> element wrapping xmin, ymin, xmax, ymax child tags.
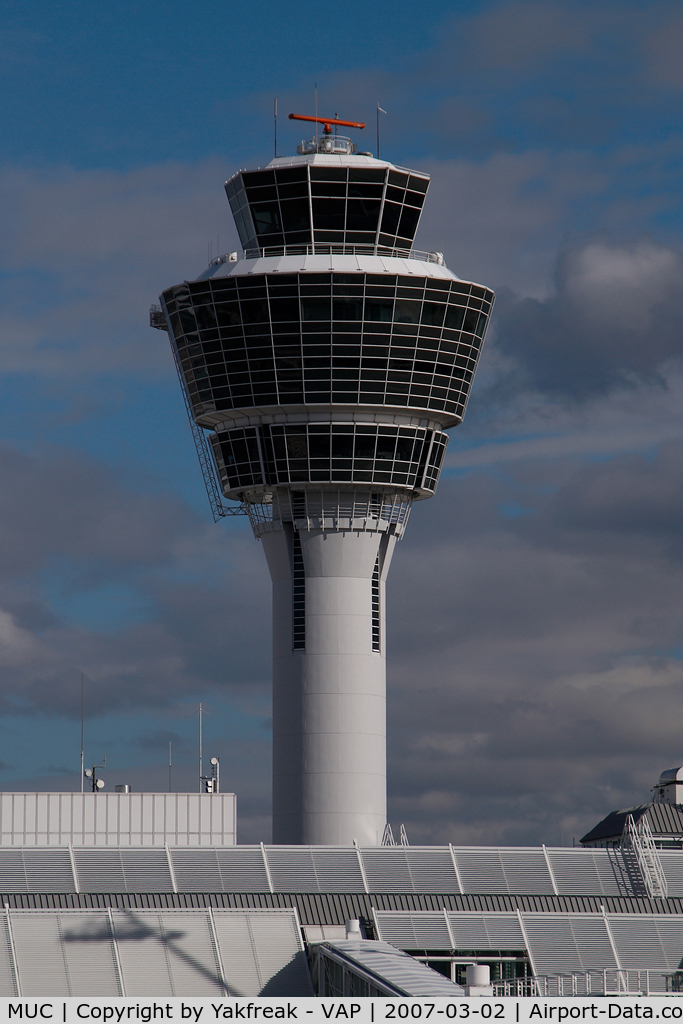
<box><xmin>316</xmin><ymin>939</ymin><xmax>465</xmax><ymax>998</ymax></box>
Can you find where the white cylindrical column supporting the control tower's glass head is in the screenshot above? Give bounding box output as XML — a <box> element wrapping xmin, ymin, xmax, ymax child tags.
<box><xmin>261</xmin><ymin>520</ymin><xmax>396</xmax><ymax>846</ymax></box>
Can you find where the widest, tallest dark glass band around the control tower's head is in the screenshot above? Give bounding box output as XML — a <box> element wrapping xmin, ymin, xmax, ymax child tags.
<box><xmin>163</xmin><ymin>272</ymin><xmax>494</xmax><ymax>423</ymax></box>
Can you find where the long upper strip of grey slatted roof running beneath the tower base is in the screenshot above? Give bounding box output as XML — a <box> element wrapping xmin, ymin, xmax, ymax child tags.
<box><xmin>0</xmin><ymin>843</ymin><xmax>683</xmax><ymax>905</ymax></box>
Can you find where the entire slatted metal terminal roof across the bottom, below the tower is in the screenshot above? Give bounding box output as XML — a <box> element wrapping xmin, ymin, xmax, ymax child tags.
<box><xmin>0</xmin><ymin>846</ymin><xmax>683</xmax><ymax>996</ymax></box>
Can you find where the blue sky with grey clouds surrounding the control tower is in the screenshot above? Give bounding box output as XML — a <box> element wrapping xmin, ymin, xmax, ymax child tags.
<box><xmin>0</xmin><ymin>0</ymin><xmax>683</xmax><ymax>845</ymax></box>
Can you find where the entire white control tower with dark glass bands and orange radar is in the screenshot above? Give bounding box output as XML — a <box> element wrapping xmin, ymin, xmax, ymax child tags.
<box><xmin>153</xmin><ymin>118</ymin><xmax>494</xmax><ymax>846</ymax></box>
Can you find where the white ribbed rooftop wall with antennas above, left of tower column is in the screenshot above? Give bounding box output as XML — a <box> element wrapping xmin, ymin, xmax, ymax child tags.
<box><xmin>0</xmin><ymin>793</ymin><xmax>237</xmax><ymax>847</ymax></box>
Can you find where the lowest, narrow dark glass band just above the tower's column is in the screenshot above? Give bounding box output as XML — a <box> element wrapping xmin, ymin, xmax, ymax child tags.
<box><xmin>210</xmin><ymin>423</ymin><xmax>449</xmax><ymax>497</ymax></box>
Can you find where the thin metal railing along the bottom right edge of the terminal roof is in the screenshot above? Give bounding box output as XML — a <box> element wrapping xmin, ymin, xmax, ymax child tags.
<box><xmin>494</xmin><ymin>970</ymin><xmax>671</xmax><ymax>998</ymax></box>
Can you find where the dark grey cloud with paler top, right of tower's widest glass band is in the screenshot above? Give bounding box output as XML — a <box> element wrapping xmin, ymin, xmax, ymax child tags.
<box><xmin>489</xmin><ymin>241</ymin><xmax>683</xmax><ymax>398</ymax></box>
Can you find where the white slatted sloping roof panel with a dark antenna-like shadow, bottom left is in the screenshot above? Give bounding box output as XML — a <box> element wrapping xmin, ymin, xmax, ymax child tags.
<box><xmin>0</xmin><ymin>908</ymin><xmax>312</xmax><ymax>996</ymax></box>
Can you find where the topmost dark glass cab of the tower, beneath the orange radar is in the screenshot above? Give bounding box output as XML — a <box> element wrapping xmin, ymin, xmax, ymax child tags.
<box><xmin>225</xmin><ymin>164</ymin><xmax>429</xmax><ymax>250</ymax></box>
